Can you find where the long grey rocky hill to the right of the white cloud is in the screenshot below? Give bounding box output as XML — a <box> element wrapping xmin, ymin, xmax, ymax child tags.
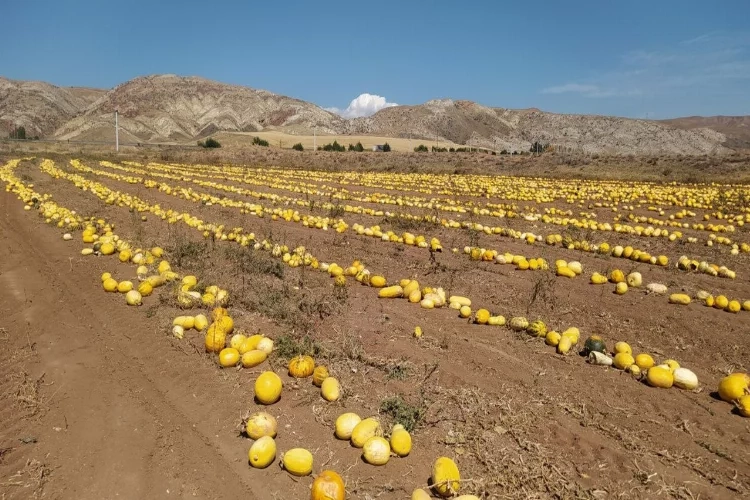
<box><xmin>351</xmin><ymin>99</ymin><xmax>728</xmax><ymax>154</ymax></box>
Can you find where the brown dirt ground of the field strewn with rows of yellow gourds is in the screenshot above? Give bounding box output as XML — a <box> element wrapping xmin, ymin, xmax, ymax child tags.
<box><xmin>0</xmin><ymin>154</ymin><xmax>750</xmax><ymax>500</ymax></box>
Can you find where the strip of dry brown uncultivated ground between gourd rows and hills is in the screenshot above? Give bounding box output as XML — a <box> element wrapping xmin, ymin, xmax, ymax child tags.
<box><xmin>5</xmin><ymin>141</ymin><xmax>750</xmax><ymax>184</ymax></box>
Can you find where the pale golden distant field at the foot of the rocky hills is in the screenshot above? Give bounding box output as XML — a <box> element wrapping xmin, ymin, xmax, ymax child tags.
<box><xmin>213</xmin><ymin>131</ymin><xmax>464</xmax><ymax>152</ymax></box>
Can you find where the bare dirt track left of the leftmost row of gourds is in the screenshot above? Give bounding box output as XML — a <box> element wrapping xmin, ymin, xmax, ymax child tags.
<box><xmin>0</xmin><ymin>193</ymin><xmax>252</xmax><ymax>498</ymax></box>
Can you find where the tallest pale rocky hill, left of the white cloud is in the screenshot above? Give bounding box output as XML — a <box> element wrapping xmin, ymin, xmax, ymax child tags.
<box><xmin>55</xmin><ymin>75</ymin><xmax>346</xmax><ymax>142</ymax></box>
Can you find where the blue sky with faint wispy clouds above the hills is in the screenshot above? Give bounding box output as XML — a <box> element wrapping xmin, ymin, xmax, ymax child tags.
<box><xmin>0</xmin><ymin>0</ymin><xmax>750</xmax><ymax>118</ymax></box>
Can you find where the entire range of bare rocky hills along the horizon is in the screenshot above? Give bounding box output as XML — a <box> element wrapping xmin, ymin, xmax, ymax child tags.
<box><xmin>0</xmin><ymin>75</ymin><xmax>750</xmax><ymax>154</ymax></box>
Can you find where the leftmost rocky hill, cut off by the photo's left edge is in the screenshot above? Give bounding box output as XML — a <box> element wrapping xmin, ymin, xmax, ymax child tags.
<box><xmin>0</xmin><ymin>76</ymin><xmax>105</xmax><ymax>137</ymax></box>
